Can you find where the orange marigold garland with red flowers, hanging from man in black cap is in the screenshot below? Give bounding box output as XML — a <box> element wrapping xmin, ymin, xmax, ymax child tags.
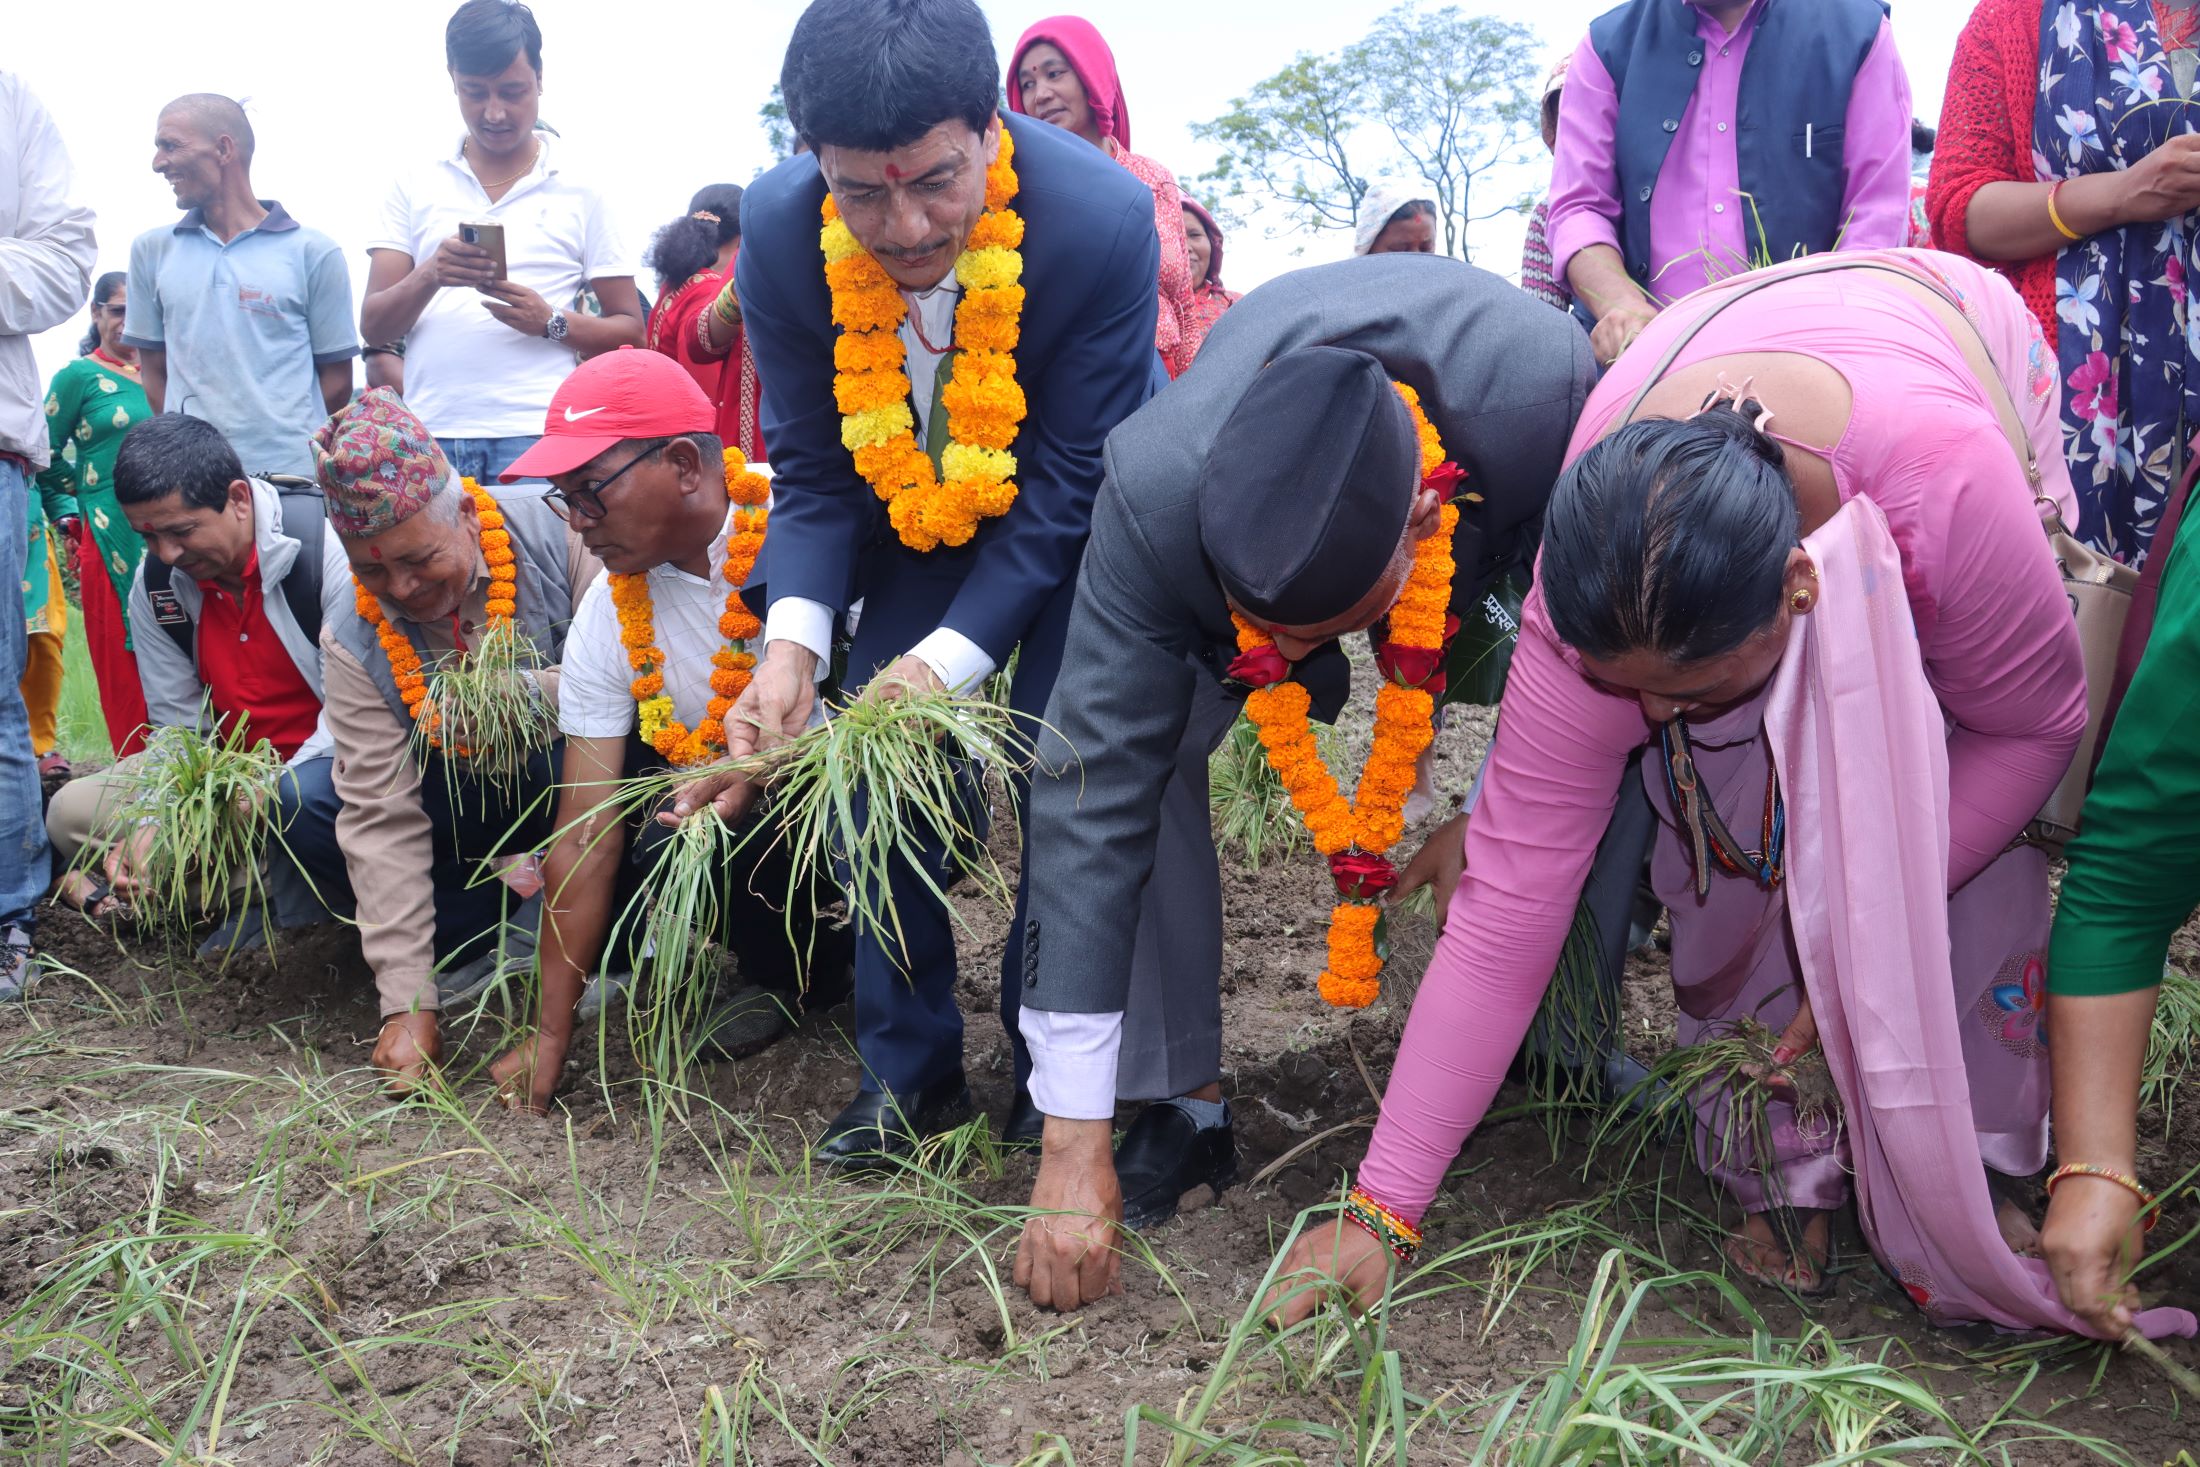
<box><xmin>1230</xmin><ymin>383</ymin><xmax>1472</xmax><ymax>1010</ymax></box>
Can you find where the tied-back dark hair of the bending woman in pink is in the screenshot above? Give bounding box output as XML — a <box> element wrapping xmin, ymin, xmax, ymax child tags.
<box><xmin>1536</xmin><ymin>411</ymin><xmax>1802</xmax><ymax>664</ymax></box>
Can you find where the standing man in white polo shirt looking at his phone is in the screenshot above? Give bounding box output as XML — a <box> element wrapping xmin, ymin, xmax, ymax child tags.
<box><xmin>359</xmin><ymin>0</ymin><xmax>642</xmax><ymax>484</ymax></box>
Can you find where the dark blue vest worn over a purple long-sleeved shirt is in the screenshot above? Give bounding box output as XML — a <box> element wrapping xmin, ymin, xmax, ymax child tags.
<box><xmin>1588</xmin><ymin>0</ymin><xmax>1888</xmax><ymax>288</ymax></box>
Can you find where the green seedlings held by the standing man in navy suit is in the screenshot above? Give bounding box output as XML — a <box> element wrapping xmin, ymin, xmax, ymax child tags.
<box><xmin>590</xmin><ymin>693</ymin><xmax>1036</xmax><ymax>1099</ymax></box>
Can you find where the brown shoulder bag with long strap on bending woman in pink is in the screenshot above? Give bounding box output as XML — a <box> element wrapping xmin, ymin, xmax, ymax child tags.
<box><xmin>1621</xmin><ymin>255</ymin><xmax>2129</xmax><ymax>849</ymax></box>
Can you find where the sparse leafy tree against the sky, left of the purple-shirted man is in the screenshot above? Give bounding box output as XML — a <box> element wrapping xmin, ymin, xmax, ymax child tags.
<box><xmin>1192</xmin><ymin>0</ymin><xmax>1544</xmax><ymax>260</ymax></box>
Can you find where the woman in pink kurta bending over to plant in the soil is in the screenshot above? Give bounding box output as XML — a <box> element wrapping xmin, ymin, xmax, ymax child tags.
<box><xmin>1285</xmin><ymin>251</ymin><xmax>2191</xmax><ymax>1333</ymax></box>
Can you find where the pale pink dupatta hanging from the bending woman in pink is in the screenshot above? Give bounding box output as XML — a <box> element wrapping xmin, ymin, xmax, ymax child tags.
<box><xmin>1764</xmin><ymin>497</ymin><xmax>2196</xmax><ymax>1337</ymax></box>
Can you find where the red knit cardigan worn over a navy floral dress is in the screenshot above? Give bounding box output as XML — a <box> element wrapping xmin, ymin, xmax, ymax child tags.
<box><xmin>1925</xmin><ymin>0</ymin><xmax>2055</xmax><ymax>343</ymax></box>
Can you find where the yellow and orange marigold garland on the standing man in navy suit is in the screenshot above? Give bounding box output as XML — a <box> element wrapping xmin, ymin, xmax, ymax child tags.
<box><xmin>818</xmin><ymin>128</ymin><xmax>1025</xmax><ymax>550</ymax></box>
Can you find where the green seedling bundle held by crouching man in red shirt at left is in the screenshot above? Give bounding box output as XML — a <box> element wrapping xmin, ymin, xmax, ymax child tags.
<box><xmin>79</xmin><ymin>715</ymin><xmax>282</xmax><ymax>933</ymax></box>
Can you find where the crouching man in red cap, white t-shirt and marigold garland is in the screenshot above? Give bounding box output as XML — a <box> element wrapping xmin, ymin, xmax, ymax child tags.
<box><xmin>491</xmin><ymin>350</ymin><xmax>856</xmax><ymax>1111</ymax></box>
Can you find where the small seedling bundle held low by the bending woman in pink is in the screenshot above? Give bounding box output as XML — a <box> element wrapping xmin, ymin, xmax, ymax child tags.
<box><xmin>1588</xmin><ymin>1018</ymin><xmax>1841</xmax><ymax>1199</ymax></box>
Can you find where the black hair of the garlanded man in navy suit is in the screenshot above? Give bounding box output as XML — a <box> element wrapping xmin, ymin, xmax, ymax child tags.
<box><xmin>779</xmin><ymin>0</ymin><xmax>1001</xmax><ymax>152</ymax></box>
